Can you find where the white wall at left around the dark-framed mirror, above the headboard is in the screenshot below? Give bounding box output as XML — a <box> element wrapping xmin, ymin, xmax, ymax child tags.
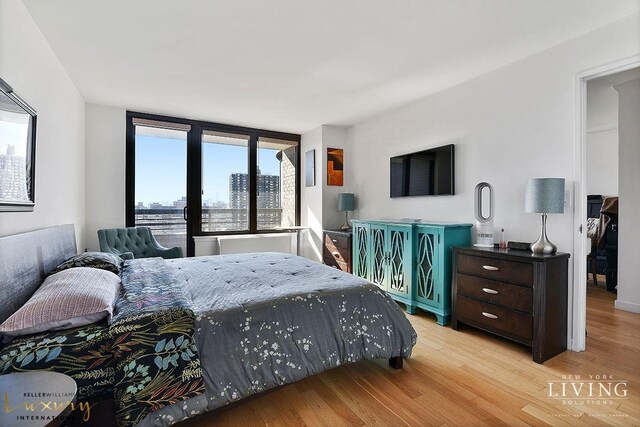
<box><xmin>0</xmin><ymin>0</ymin><xmax>85</xmax><ymax>250</ymax></box>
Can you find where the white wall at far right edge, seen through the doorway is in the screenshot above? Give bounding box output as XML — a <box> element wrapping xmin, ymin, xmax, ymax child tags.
<box><xmin>615</xmin><ymin>79</ymin><xmax>640</xmax><ymax>313</ymax></box>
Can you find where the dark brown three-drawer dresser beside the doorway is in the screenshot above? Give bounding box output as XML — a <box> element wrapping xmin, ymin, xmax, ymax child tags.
<box><xmin>451</xmin><ymin>247</ymin><xmax>569</xmax><ymax>363</ymax></box>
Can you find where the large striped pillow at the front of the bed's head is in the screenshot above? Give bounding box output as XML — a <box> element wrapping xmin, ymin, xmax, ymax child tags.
<box><xmin>0</xmin><ymin>267</ymin><xmax>120</xmax><ymax>336</ymax></box>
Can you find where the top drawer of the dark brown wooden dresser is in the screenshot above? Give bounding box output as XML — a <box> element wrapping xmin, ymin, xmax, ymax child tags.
<box><xmin>457</xmin><ymin>254</ymin><xmax>533</xmax><ymax>286</ymax></box>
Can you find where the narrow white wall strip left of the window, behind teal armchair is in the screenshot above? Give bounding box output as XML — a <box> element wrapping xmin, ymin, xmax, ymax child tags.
<box><xmin>85</xmin><ymin>104</ymin><xmax>126</xmax><ymax>250</ymax></box>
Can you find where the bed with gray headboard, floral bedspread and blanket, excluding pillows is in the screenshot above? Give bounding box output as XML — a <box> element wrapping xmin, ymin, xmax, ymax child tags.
<box><xmin>0</xmin><ymin>226</ymin><xmax>416</xmax><ymax>426</ymax></box>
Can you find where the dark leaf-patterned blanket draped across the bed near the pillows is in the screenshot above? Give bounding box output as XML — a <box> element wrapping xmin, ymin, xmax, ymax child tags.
<box><xmin>0</xmin><ymin>258</ymin><xmax>205</xmax><ymax>426</ymax></box>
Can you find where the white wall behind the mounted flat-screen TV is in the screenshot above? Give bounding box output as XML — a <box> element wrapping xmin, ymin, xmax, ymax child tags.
<box><xmin>347</xmin><ymin>14</ymin><xmax>640</xmax><ymax>334</ymax></box>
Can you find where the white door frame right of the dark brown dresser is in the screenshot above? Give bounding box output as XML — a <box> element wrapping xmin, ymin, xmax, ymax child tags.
<box><xmin>568</xmin><ymin>55</ymin><xmax>640</xmax><ymax>351</ymax></box>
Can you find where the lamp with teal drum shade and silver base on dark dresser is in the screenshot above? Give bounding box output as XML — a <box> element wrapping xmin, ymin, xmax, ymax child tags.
<box><xmin>524</xmin><ymin>178</ymin><xmax>564</xmax><ymax>254</ymax></box>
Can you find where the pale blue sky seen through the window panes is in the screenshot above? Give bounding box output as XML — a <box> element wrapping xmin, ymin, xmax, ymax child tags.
<box><xmin>135</xmin><ymin>135</ymin><xmax>280</xmax><ymax>206</ymax></box>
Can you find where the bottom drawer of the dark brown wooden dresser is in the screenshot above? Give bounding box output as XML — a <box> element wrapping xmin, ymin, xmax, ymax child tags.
<box><xmin>455</xmin><ymin>295</ymin><xmax>533</xmax><ymax>345</ymax></box>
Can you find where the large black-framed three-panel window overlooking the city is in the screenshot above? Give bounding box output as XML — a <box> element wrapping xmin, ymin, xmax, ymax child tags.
<box><xmin>126</xmin><ymin>112</ymin><xmax>300</xmax><ymax>255</ymax></box>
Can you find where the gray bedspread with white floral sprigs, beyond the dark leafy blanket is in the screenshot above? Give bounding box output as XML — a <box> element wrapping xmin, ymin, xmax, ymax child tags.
<box><xmin>141</xmin><ymin>253</ymin><xmax>416</xmax><ymax>425</ymax></box>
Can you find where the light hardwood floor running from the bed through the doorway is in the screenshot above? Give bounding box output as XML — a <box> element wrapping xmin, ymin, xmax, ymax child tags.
<box><xmin>181</xmin><ymin>285</ymin><xmax>640</xmax><ymax>426</ymax></box>
